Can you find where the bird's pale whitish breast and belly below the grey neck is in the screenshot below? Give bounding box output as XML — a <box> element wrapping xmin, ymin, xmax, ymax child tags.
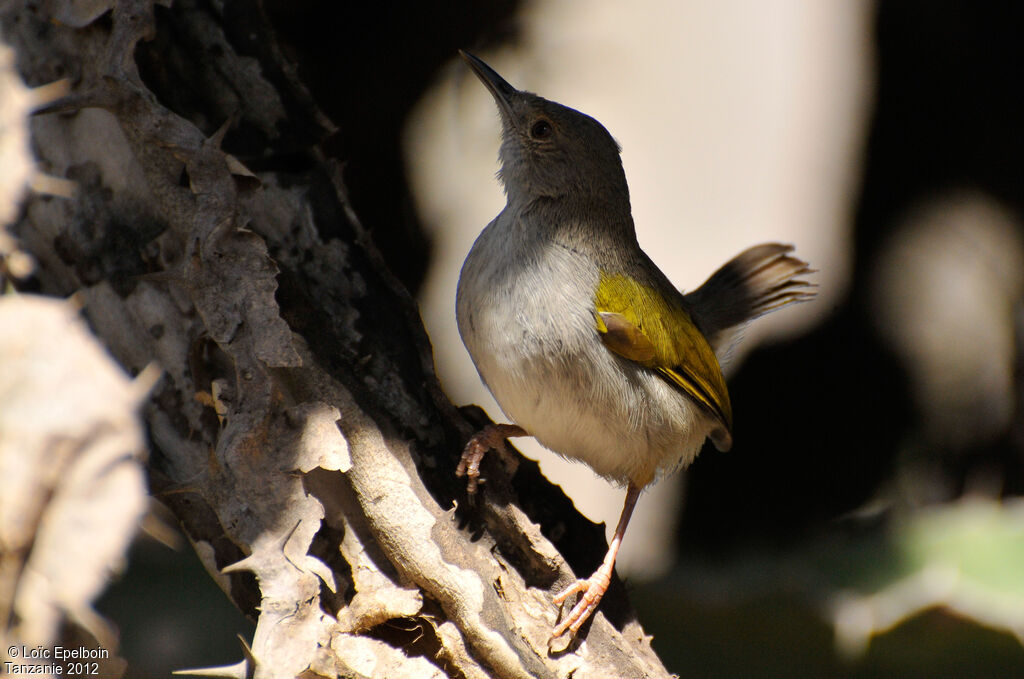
<box><xmin>458</xmin><ymin>235</ymin><xmax>710</xmax><ymax>486</ymax></box>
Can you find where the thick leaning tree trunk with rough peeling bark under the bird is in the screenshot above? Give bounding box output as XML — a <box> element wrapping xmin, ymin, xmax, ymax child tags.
<box><xmin>0</xmin><ymin>0</ymin><xmax>667</xmax><ymax>678</ymax></box>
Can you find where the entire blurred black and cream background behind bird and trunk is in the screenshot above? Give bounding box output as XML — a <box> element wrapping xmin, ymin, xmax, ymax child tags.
<box><xmin>86</xmin><ymin>0</ymin><xmax>1024</xmax><ymax>678</ymax></box>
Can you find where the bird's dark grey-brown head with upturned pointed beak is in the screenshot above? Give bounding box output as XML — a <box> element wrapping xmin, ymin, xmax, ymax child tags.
<box><xmin>460</xmin><ymin>52</ymin><xmax>629</xmax><ymax>209</ymax></box>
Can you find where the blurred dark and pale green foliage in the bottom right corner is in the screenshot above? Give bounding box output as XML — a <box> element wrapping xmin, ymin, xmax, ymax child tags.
<box><xmin>632</xmin><ymin>499</ymin><xmax>1024</xmax><ymax>679</ymax></box>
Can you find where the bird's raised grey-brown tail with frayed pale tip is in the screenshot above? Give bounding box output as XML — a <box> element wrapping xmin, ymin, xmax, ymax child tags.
<box><xmin>685</xmin><ymin>243</ymin><xmax>817</xmax><ymax>357</ymax></box>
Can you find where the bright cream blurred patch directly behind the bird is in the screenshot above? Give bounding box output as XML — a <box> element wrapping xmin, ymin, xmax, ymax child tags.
<box><xmin>406</xmin><ymin>0</ymin><xmax>871</xmax><ymax>577</ymax></box>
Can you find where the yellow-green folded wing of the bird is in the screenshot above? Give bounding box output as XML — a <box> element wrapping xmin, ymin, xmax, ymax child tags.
<box><xmin>594</xmin><ymin>274</ymin><xmax>732</xmax><ymax>448</ymax></box>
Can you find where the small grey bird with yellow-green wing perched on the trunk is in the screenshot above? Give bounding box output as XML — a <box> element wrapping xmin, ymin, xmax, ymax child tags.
<box><xmin>456</xmin><ymin>50</ymin><xmax>816</xmax><ymax>641</ymax></box>
